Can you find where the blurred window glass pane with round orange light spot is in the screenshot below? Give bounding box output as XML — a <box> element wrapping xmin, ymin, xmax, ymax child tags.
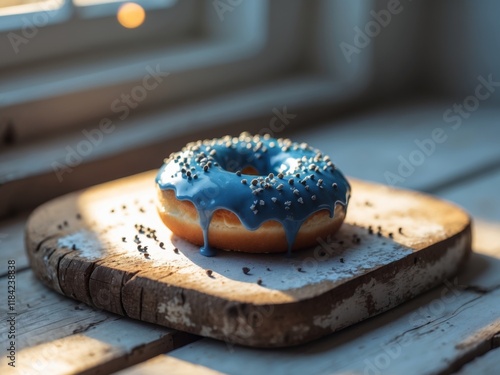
<box><xmin>0</xmin><ymin>0</ymin><xmax>188</xmax><ymax>68</ymax></box>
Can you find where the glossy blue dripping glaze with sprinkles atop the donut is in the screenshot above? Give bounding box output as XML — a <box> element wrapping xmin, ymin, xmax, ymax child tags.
<box><xmin>156</xmin><ymin>133</ymin><xmax>351</xmax><ymax>256</ymax></box>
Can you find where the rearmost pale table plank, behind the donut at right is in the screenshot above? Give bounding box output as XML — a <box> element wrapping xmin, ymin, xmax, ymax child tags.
<box><xmin>296</xmin><ymin>102</ymin><xmax>500</xmax><ymax>191</ymax></box>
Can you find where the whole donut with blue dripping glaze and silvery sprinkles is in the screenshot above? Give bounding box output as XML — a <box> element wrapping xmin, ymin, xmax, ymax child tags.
<box><xmin>156</xmin><ymin>133</ymin><xmax>351</xmax><ymax>256</ymax></box>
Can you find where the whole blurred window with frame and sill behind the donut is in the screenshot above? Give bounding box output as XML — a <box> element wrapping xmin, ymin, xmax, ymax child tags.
<box><xmin>0</xmin><ymin>0</ymin><xmax>371</xmax><ymax>217</ymax></box>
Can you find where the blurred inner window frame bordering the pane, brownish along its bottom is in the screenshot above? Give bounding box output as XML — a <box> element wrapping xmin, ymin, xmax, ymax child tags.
<box><xmin>0</xmin><ymin>0</ymin><xmax>274</xmax><ymax>141</ymax></box>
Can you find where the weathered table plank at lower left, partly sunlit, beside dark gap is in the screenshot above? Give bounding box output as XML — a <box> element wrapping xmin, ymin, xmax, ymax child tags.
<box><xmin>0</xmin><ymin>270</ymin><xmax>196</xmax><ymax>374</ymax></box>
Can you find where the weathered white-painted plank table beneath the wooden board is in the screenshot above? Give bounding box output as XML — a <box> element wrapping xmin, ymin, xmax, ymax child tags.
<box><xmin>0</xmin><ymin>103</ymin><xmax>500</xmax><ymax>374</ymax></box>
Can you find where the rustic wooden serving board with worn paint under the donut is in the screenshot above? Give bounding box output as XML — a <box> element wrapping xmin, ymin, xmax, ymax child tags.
<box><xmin>26</xmin><ymin>171</ymin><xmax>471</xmax><ymax>347</ymax></box>
